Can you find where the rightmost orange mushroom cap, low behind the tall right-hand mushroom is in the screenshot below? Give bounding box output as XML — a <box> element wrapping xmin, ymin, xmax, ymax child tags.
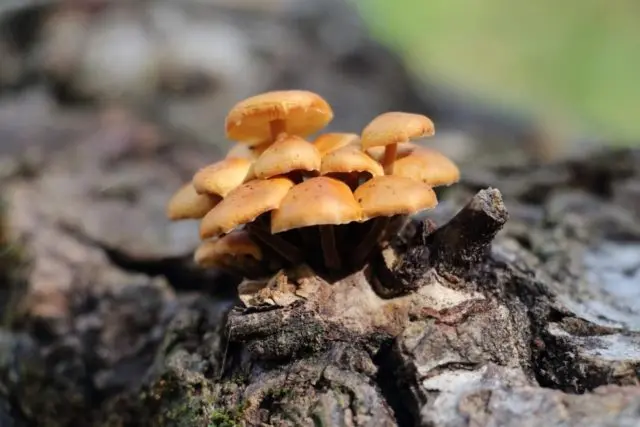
<box><xmin>393</xmin><ymin>147</ymin><xmax>460</xmax><ymax>187</ymax></box>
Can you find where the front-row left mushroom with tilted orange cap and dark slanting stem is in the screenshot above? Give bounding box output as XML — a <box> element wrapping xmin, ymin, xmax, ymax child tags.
<box><xmin>200</xmin><ymin>177</ymin><xmax>301</xmax><ymax>263</ymax></box>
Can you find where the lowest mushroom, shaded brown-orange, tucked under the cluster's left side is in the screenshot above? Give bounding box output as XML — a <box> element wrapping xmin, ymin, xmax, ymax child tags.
<box><xmin>193</xmin><ymin>230</ymin><xmax>267</xmax><ymax>278</ymax></box>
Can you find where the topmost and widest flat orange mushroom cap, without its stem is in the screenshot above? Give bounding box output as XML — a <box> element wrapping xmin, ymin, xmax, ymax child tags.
<box><xmin>225</xmin><ymin>90</ymin><xmax>333</xmax><ymax>145</ymax></box>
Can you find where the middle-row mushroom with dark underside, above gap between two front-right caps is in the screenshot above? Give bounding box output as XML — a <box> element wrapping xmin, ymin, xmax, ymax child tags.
<box><xmin>320</xmin><ymin>145</ymin><xmax>384</xmax><ymax>190</ymax></box>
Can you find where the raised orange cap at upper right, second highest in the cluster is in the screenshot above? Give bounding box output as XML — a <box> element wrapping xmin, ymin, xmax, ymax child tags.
<box><xmin>362</xmin><ymin>111</ymin><xmax>435</xmax><ymax>149</ymax></box>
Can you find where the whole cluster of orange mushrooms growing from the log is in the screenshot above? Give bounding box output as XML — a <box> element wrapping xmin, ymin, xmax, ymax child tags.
<box><xmin>167</xmin><ymin>90</ymin><xmax>459</xmax><ymax>279</ymax></box>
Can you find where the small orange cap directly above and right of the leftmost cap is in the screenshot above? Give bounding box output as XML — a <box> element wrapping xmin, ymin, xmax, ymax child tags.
<box><xmin>191</xmin><ymin>157</ymin><xmax>251</xmax><ymax>197</ymax></box>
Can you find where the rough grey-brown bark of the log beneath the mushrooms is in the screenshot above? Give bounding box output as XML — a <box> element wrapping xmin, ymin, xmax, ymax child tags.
<box><xmin>0</xmin><ymin>110</ymin><xmax>640</xmax><ymax>426</ymax></box>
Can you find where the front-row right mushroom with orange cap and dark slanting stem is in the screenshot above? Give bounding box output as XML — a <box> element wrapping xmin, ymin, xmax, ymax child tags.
<box><xmin>352</xmin><ymin>175</ymin><xmax>438</xmax><ymax>266</ymax></box>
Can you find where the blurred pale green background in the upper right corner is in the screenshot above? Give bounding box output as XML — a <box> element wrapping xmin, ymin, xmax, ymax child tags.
<box><xmin>356</xmin><ymin>0</ymin><xmax>640</xmax><ymax>144</ymax></box>
